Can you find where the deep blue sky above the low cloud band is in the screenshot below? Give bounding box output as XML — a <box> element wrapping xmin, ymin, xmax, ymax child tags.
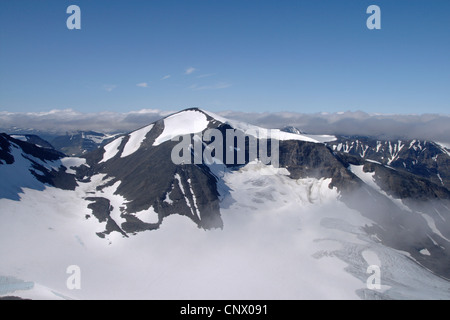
<box><xmin>0</xmin><ymin>0</ymin><xmax>450</xmax><ymax>114</ymax></box>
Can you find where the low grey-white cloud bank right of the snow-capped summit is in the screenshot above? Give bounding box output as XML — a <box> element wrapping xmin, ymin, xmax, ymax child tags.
<box><xmin>216</xmin><ymin>111</ymin><xmax>450</xmax><ymax>142</ymax></box>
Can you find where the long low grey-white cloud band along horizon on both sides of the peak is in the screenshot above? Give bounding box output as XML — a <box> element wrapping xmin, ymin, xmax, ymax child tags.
<box><xmin>0</xmin><ymin>109</ymin><xmax>450</xmax><ymax>143</ymax></box>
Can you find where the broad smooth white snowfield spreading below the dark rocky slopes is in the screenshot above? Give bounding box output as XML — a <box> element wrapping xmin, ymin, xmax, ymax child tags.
<box><xmin>0</xmin><ymin>162</ymin><xmax>450</xmax><ymax>299</ymax></box>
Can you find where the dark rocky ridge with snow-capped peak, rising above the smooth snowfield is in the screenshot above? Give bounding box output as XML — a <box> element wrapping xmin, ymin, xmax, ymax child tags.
<box><xmin>0</xmin><ymin>108</ymin><xmax>450</xmax><ymax>298</ymax></box>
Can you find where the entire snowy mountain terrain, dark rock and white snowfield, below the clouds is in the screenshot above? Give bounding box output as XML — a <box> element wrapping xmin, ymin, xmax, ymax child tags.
<box><xmin>0</xmin><ymin>109</ymin><xmax>450</xmax><ymax>299</ymax></box>
